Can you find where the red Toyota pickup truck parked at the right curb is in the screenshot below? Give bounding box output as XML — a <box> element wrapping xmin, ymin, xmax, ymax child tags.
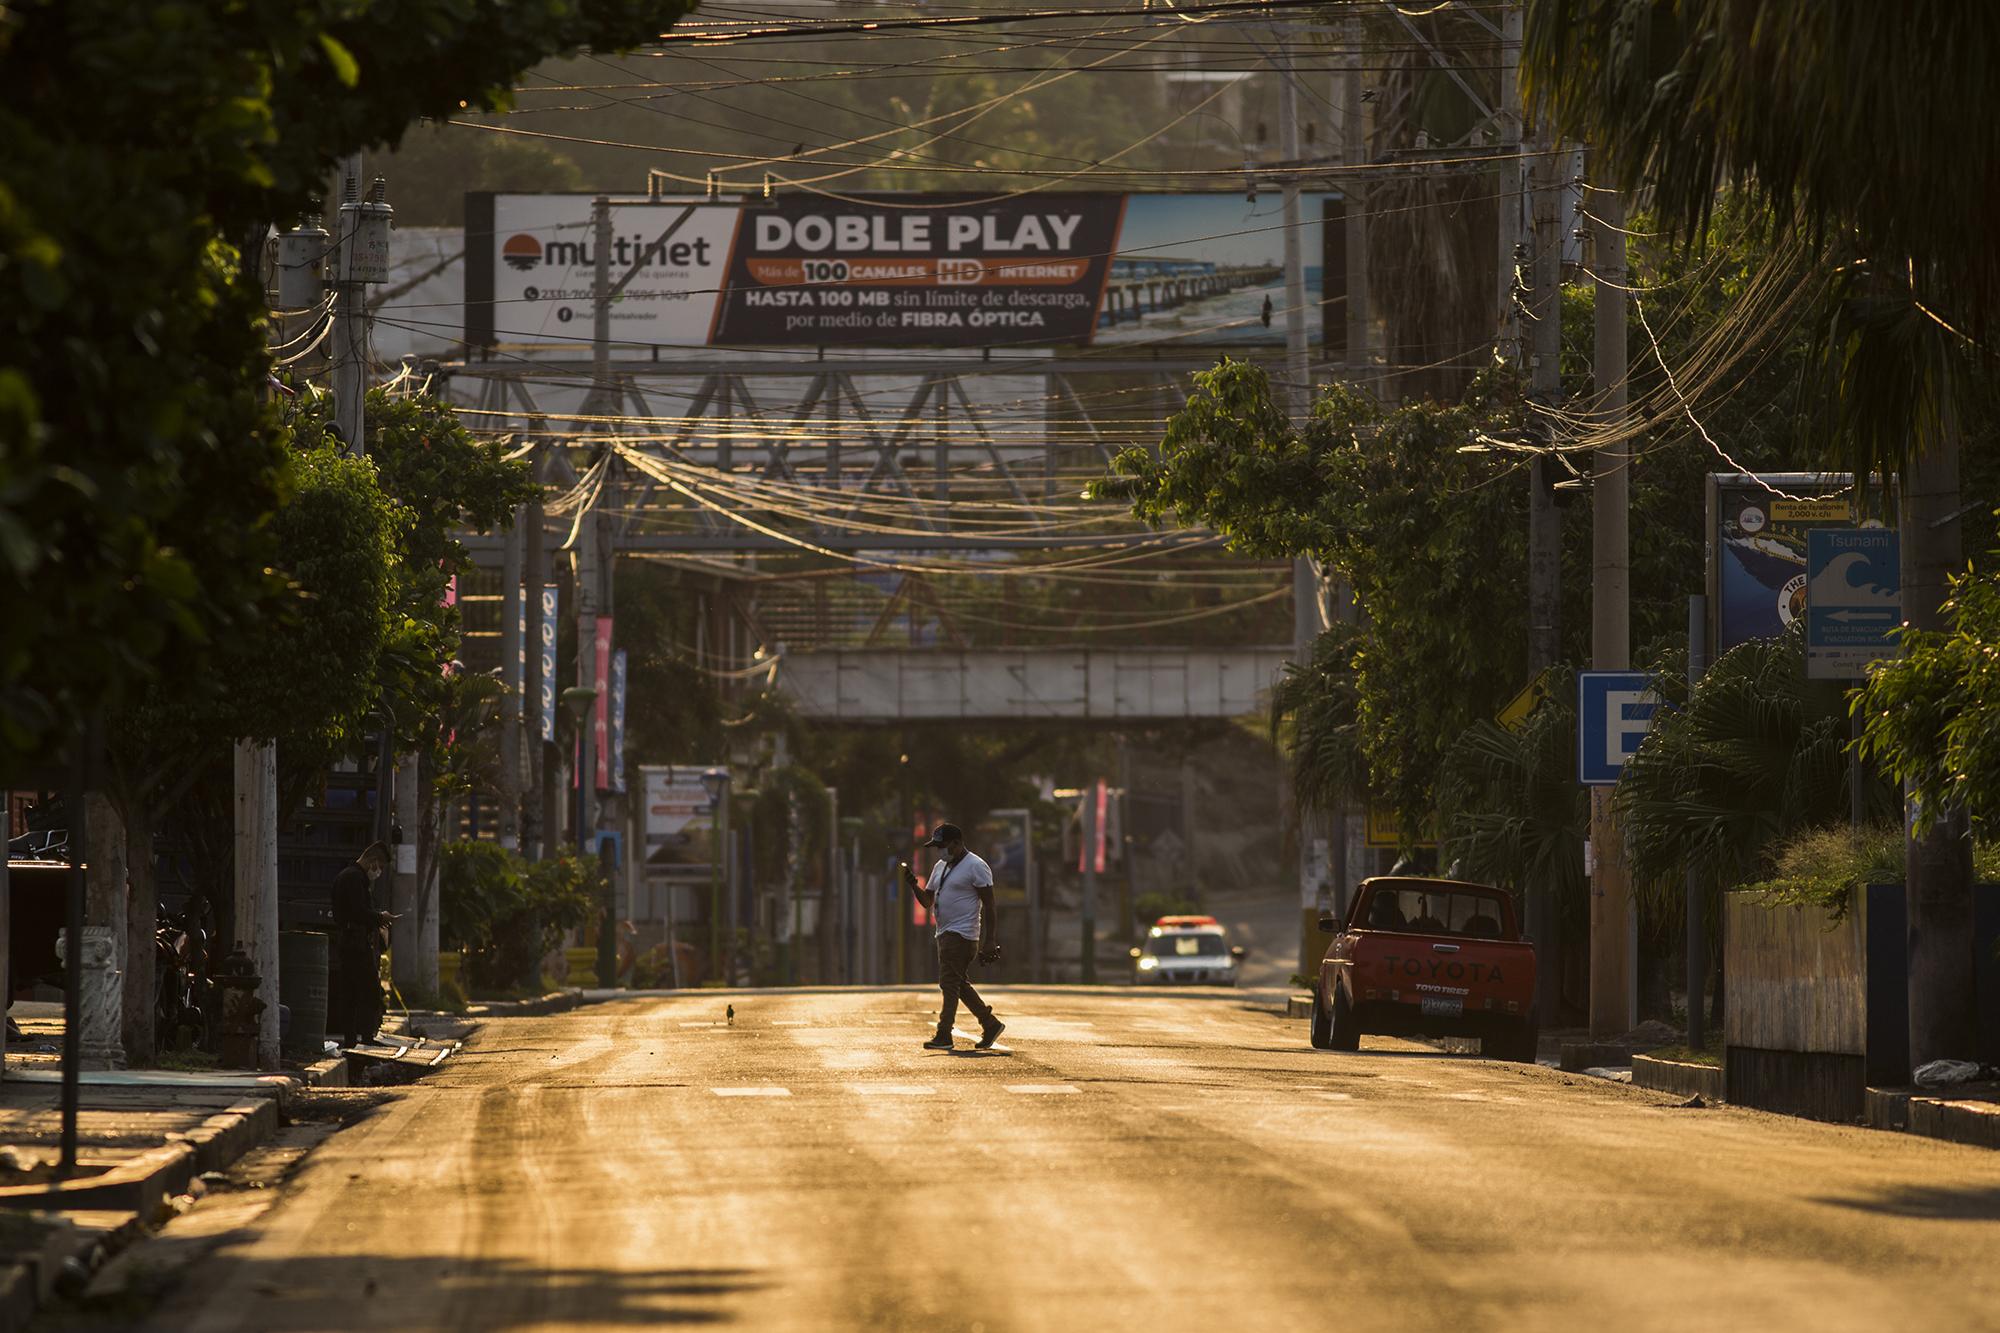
<box><xmin>1312</xmin><ymin>877</ymin><xmax>1538</xmax><ymax>1061</ymax></box>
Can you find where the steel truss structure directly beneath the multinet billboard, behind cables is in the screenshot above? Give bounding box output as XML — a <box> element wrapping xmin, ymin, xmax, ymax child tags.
<box><xmin>444</xmin><ymin>356</ymin><xmax>1312</xmax><ymax>554</ymax></box>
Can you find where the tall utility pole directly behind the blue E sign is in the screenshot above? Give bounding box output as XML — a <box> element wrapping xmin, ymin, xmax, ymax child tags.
<box><xmin>1584</xmin><ymin>190</ymin><xmax>1632</xmax><ymax>1039</ymax></box>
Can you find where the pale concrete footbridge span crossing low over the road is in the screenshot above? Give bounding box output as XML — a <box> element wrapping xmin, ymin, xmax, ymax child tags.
<box><xmin>776</xmin><ymin>646</ymin><xmax>1292</xmax><ymax>723</ymax></box>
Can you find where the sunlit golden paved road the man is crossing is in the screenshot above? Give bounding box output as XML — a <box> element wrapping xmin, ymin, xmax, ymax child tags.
<box><xmin>156</xmin><ymin>989</ymin><xmax>2000</xmax><ymax>1333</ymax></box>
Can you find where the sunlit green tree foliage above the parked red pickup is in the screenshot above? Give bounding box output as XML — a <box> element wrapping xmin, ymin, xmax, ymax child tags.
<box><xmin>1100</xmin><ymin>360</ymin><xmax>1528</xmax><ymax>829</ymax></box>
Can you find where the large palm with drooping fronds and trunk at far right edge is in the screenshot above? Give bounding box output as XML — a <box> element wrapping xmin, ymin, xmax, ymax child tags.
<box><xmin>1522</xmin><ymin>0</ymin><xmax>2000</xmax><ymax>1063</ymax></box>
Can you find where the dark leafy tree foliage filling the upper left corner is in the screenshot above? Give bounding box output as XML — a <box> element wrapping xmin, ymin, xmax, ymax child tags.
<box><xmin>0</xmin><ymin>0</ymin><xmax>684</xmax><ymax>771</ymax></box>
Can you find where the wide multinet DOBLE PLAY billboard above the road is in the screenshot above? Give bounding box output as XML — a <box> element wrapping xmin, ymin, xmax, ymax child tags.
<box><xmin>464</xmin><ymin>190</ymin><xmax>1340</xmax><ymax>356</ymax></box>
